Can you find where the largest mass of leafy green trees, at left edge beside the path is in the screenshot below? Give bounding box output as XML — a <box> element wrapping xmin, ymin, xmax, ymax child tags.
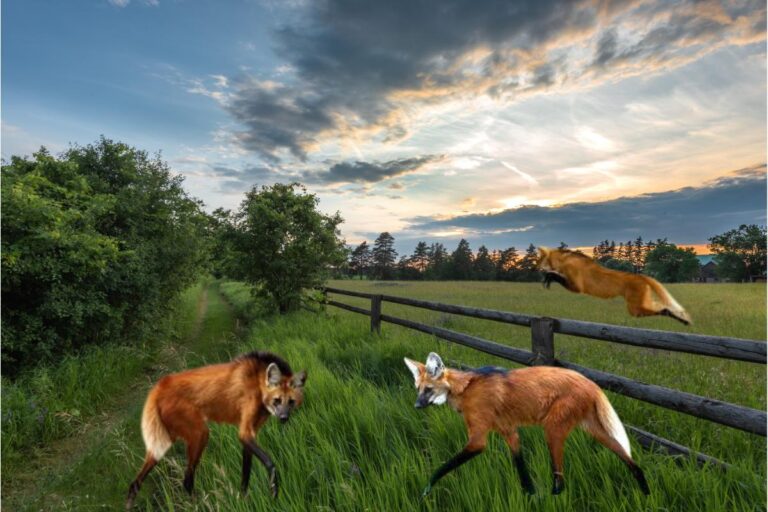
<box><xmin>2</xmin><ymin>138</ymin><xmax>210</xmax><ymax>375</ymax></box>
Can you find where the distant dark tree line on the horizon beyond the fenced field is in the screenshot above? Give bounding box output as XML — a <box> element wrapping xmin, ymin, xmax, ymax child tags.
<box><xmin>344</xmin><ymin>228</ymin><xmax>766</xmax><ymax>283</ymax></box>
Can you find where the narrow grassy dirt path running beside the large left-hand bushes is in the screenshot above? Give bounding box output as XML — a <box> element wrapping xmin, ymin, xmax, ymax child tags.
<box><xmin>3</xmin><ymin>284</ymin><xmax>235</xmax><ymax>510</ymax></box>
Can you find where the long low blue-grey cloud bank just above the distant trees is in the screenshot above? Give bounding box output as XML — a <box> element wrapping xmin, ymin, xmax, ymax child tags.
<box><xmin>408</xmin><ymin>165</ymin><xmax>766</xmax><ymax>247</ymax></box>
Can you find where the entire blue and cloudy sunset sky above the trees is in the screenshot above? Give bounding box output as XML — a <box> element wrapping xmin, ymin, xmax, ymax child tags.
<box><xmin>1</xmin><ymin>0</ymin><xmax>766</xmax><ymax>254</ymax></box>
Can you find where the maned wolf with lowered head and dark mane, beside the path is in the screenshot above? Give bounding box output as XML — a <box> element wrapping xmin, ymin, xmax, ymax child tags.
<box><xmin>126</xmin><ymin>352</ymin><xmax>307</xmax><ymax>508</ymax></box>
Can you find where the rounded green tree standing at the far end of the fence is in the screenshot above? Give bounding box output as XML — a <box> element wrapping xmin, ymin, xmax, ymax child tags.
<box><xmin>228</xmin><ymin>183</ymin><xmax>346</xmax><ymax>313</ymax></box>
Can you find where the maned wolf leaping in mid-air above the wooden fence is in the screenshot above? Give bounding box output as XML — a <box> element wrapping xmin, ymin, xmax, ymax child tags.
<box><xmin>538</xmin><ymin>247</ymin><xmax>691</xmax><ymax>325</ymax></box>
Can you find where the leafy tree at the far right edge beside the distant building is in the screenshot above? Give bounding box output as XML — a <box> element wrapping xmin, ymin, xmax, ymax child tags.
<box><xmin>709</xmin><ymin>224</ymin><xmax>766</xmax><ymax>281</ymax></box>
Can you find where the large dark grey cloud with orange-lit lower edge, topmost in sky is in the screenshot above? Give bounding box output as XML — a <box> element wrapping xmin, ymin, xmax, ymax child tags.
<box><xmin>218</xmin><ymin>0</ymin><xmax>766</xmax><ymax>162</ymax></box>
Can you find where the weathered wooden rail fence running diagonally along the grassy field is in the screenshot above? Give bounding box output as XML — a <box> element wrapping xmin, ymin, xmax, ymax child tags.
<box><xmin>323</xmin><ymin>288</ymin><xmax>766</xmax><ymax>467</ymax></box>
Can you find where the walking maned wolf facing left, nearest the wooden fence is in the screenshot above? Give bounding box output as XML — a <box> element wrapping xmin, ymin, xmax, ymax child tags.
<box><xmin>405</xmin><ymin>352</ymin><xmax>649</xmax><ymax>496</ymax></box>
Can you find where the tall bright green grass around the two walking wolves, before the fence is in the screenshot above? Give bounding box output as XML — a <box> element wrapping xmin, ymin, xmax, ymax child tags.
<box><xmin>147</xmin><ymin>284</ymin><xmax>766</xmax><ymax>511</ymax></box>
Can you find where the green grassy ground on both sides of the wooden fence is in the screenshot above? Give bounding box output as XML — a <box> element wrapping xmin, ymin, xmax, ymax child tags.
<box><xmin>9</xmin><ymin>281</ymin><xmax>766</xmax><ymax>511</ymax></box>
